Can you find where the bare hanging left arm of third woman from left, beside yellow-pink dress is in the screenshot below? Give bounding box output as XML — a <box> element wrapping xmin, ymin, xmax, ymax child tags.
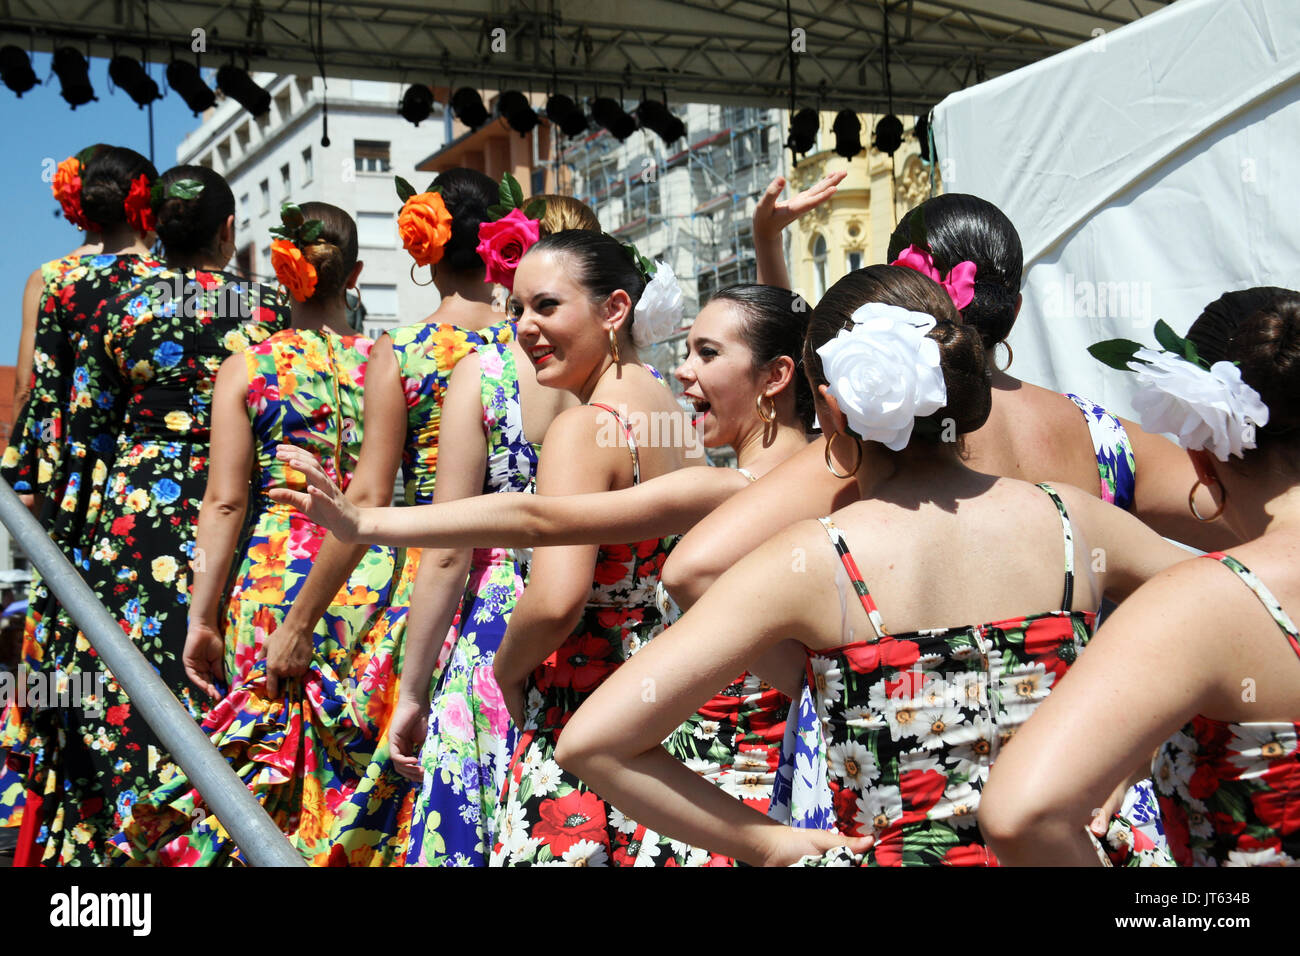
<box><xmin>183</xmin><ymin>355</ymin><xmax>254</xmax><ymax>700</ymax></box>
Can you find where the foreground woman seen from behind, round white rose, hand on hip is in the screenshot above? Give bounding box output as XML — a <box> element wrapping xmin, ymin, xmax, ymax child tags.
<box><xmin>556</xmin><ymin>267</ymin><xmax>1180</xmax><ymax>865</ymax></box>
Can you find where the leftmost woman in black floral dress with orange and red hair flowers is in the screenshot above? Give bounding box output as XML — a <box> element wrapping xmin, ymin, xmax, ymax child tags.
<box><xmin>0</xmin><ymin>147</ymin><xmax>163</xmax><ymax>865</ymax></box>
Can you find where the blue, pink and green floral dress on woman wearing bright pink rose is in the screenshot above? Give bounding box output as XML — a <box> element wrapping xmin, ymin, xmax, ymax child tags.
<box><xmin>408</xmin><ymin>345</ymin><xmax>537</xmax><ymax>866</ymax></box>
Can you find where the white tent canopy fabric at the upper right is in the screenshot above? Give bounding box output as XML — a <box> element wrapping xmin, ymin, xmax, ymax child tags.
<box><xmin>935</xmin><ymin>0</ymin><xmax>1300</xmax><ymax>414</ymax></box>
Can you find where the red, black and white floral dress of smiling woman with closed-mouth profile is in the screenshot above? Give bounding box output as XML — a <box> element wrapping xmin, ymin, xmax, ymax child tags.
<box><xmin>489</xmin><ymin>395</ymin><xmax>686</xmax><ymax>866</ymax></box>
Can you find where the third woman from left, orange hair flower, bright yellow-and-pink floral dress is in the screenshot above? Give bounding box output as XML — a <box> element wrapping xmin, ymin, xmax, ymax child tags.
<box><xmin>113</xmin><ymin>203</ymin><xmax>394</xmax><ymax>866</ymax></box>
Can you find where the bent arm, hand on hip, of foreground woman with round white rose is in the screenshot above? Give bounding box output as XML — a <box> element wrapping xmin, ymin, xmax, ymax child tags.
<box><xmin>555</xmin><ymin>524</ymin><xmax>871</xmax><ymax>865</ymax></box>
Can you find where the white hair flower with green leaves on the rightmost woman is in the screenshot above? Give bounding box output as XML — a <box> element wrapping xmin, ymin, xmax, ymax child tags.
<box><xmin>1088</xmin><ymin>321</ymin><xmax>1269</xmax><ymax>462</ymax></box>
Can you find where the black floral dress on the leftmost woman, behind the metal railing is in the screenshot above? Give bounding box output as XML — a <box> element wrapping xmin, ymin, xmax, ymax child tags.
<box><xmin>0</xmin><ymin>255</ymin><xmax>163</xmax><ymax>862</ymax></box>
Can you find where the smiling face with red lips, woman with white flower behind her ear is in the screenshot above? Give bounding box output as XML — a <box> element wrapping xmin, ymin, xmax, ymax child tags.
<box><xmin>508</xmin><ymin>250</ymin><xmax>611</xmax><ymax>395</ymax></box>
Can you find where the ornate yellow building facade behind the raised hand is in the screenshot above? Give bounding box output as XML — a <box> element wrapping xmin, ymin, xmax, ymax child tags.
<box><xmin>788</xmin><ymin>113</ymin><xmax>941</xmax><ymax>304</ymax></box>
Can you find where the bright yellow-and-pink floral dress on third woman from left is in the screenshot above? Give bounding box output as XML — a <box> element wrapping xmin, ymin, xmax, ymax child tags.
<box><xmin>113</xmin><ymin>329</ymin><xmax>397</xmax><ymax>866</ymax></box>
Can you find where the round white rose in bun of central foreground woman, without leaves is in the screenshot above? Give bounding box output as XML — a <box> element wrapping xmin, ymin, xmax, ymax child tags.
<box><xmin>816</xmin><ymin>302</ymin><xmax>948</xmax><ymax>451</ymax></box>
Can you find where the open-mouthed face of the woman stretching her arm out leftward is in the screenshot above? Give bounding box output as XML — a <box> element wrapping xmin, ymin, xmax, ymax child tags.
<box><xmin>673</xmin><ymin>300</ymin><xmax>763</xmax><ymax>449</ymax></box>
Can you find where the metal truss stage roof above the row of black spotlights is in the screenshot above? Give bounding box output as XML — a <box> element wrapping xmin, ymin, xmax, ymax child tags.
<box><xmin>0</xmin><ymin>0</ymin><xmax>1170</xmax><ymax>113</ymax></box>
